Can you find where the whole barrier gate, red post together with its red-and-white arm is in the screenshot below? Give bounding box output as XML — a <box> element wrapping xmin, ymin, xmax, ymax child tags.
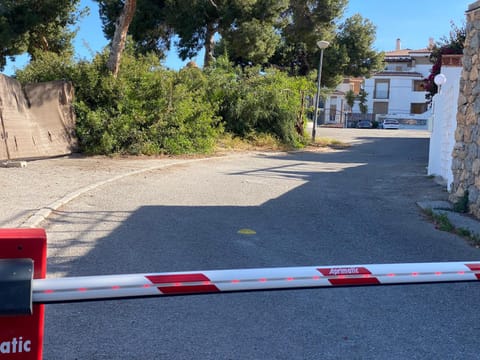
<box><xmin>0</xmin><ymin>229</ymin><xmax>480</xmax><ymax>360</ymax></box>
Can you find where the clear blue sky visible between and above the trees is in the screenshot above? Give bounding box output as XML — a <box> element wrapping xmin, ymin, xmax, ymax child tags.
<box><xmin>4</xmin><ymin>0</ymin><xmax>474</xmax><ymax>75</ymax></box>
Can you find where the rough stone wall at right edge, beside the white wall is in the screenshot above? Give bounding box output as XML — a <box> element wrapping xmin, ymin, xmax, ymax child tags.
<box><xmin>450</xmin><ymin>1</ymin><xmax>480</xmax><ymax>218</ymax></box>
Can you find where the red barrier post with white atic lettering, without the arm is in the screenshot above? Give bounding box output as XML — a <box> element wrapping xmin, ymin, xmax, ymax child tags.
<box><xmin>0</xmin><ymin>229</ymin><xmax>47</xmax><ymax>360</ymax></box>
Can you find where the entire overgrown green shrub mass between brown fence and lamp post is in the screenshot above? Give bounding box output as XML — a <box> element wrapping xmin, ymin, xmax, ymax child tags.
<box><xmin>17</xmin><ymin>48</ymin><xmax>315</xmax><ymax>155</ymax></box>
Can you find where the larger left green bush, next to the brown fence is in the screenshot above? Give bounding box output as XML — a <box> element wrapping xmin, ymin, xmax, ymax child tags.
<box><xmin>18</xmin><ymin>51</ymin><xmax>222</xmax><ymax>155</ymax></box>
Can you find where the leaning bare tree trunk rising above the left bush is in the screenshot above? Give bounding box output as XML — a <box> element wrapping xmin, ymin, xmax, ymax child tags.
<box><xmin>107</xmin><ymin>0</ymin><xmax>137</xmax><ymax>77</ymax></box>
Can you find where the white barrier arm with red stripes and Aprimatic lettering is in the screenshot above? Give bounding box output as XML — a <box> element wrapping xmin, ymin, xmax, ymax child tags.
<box><xmin>32</xmin><ymin>262</ymin><xmax>480</xmax><ymax>303</ymax></box>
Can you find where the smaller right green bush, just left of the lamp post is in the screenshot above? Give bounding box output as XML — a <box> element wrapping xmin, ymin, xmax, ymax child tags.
<box><xmin>210</xmin><ymin>62</ymin><xmax>315</xmax><ymax>147</ymax></box>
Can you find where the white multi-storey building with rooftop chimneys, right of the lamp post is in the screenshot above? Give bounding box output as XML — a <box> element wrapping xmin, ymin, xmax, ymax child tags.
<box><xmin>364</xmin><ymin>39</ymin><xmax>433</xmax><ymax>125</ymax></box>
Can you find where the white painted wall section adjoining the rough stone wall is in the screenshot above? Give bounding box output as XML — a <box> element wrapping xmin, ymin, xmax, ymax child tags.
<box><xmin>428</xmin><ymin>66</ymin><xmax>462</xmax><ymax>191</ymax></box>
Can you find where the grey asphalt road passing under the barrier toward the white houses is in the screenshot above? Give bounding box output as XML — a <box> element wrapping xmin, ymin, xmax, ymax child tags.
<box><xmin>43</xmin><ymin>129</ymin><xmax>480</xmax><ymax>359</ymax></box>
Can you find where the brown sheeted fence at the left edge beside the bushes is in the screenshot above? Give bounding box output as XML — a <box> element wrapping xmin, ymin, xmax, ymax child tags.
<box><xmin>0</xmin><ymin>74</ymin><xmax>77</xmax><ymax>160</ymax></box>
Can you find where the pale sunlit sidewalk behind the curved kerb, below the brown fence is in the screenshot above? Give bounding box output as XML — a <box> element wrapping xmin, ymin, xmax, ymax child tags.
<box><xmin>0</xmin><ymin>155</ymin><xmax>218</xmax><ymax>228</ymax></box>
